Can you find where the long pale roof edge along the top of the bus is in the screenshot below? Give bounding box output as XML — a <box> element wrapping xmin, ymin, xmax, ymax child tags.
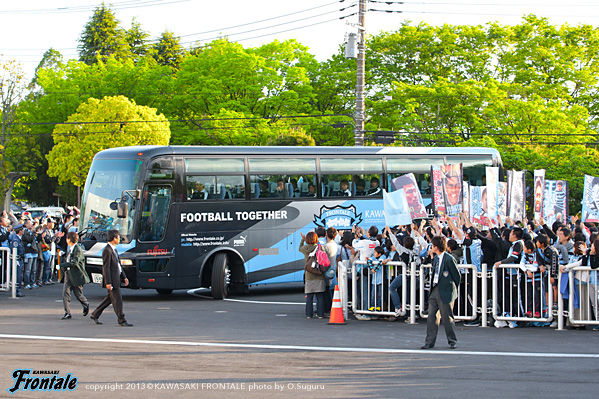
<box><xmin>94</xmin><ymin>146</ymin><xmax>501</xmax><ymax>164</ymax></box>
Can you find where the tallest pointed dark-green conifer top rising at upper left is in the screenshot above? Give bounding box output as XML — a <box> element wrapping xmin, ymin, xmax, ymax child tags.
<box><xmin>77</xmin><ymin>3</ymin><xmax>130</xmax><ymax>64</ymax></box>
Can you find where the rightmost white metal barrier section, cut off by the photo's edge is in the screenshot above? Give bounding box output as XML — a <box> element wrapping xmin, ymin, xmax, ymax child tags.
<box><xmin>559</xmin><ymin>266</ymin><xmax>599</xmax><ymax>325</ymax></box>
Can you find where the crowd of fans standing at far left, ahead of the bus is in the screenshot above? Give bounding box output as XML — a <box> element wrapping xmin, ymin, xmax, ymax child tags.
<box><xmin>0</xmin><ymin>207</ymin><xmax>79</xmax><ymax>297</ymax></box>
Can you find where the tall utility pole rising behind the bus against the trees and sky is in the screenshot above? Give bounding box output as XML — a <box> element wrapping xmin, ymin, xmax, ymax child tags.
<box><xmin>354</xmin><ymin>0</ymin><xmax>366</xmax><ymax>147</ymax></box>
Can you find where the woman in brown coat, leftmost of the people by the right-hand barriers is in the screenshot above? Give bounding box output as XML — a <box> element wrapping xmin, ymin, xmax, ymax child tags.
<box><xmin>299</xmin><ymin>231</ymin><xmax>325</xmax><ymax>319</ymax></box>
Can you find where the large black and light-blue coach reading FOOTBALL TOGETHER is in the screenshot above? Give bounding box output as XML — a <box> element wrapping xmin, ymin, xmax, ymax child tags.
<box><xmin>80</xmin><ymin>146</ymin><xmax>501</xmax><ymax>299</ymax></box>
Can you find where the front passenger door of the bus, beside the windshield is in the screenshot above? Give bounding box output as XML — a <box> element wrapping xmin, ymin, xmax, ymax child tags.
<box><xmin>137</xmin><ymin>184</ymin><xmax>177</xmax><ymax>289</ymax></box>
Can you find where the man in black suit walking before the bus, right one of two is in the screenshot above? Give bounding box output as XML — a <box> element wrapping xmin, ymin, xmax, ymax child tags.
<box><xmin>89</xmin><ymin>230</ymin><xmax>133</xmax><ymax>327</ymax></box>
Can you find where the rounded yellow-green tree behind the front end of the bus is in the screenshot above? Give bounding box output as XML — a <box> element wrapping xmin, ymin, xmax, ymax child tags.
<box><xmin>47</xmin><ymin>96</ymin><xmax>171</xmax><ymax>187</ymax></box>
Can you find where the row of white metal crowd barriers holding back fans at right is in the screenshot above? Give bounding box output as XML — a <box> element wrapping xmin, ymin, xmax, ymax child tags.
<box><xmin>342</xmin><ymin>261</ymin><xmax>599</xmax><ymax>330</ymax></box>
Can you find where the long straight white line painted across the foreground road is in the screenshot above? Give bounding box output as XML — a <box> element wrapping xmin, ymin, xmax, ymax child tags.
<box><xmin>0</xmin><ymin>334</ymin><xmax>599</xmax><ymax>359</ymax></box>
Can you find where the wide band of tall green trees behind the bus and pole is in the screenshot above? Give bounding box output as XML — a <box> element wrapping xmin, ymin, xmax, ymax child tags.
<box><xmin>14</xmin><ymin>5</ymin><xmax>599</xmax><ymax>214</ymax></box>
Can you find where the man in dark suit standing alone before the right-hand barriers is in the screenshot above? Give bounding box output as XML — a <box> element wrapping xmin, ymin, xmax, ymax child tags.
<box><xmin>421</xmin><ymin>236</ymin><xmax>460</xmax><ymax>349</ymax></box>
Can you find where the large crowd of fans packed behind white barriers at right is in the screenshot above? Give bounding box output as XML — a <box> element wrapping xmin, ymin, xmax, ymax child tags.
<box><xmin>306</xmin><ymin>214</ymin><xmax>599</xmax><ymax>330</ymax></box>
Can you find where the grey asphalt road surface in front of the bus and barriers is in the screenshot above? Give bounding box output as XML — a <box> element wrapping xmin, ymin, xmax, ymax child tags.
<box><xmin>0</xmin><ymin>285</ymin><xmax>599</xmax><ymax>398</ymax></box>
